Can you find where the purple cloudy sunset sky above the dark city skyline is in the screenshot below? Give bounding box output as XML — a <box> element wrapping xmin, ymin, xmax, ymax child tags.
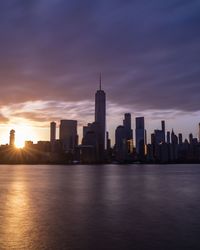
<box><xmin>0</xmin><ymin>0</ymin><xmax>200</xmax><ymax>144</ymax></box>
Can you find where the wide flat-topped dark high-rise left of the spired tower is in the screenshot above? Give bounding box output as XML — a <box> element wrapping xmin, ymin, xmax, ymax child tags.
<box><xmin>59</xmin><ymin>120</ymin><xmax>78</xmax><ymax>151</ymax></box>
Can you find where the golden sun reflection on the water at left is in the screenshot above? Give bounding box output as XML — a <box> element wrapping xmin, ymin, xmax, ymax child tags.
<box><xmin>0</xmin><ymin>168</ymin><xmax>33</xmax><ymax>249</ymax></box>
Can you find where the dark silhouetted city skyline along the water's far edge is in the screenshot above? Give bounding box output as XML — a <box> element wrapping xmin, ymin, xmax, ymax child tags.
<box><xmin>0</xmin><ymin>67</ymin><xmax>200</xmax><ymax>164</ymax></box>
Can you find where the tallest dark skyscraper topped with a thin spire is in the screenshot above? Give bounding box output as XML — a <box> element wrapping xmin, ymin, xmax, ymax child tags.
<box><xmin>95</xmin><ymin>74</ymin><xmax>106</xmax><ymax>161</ymax></box>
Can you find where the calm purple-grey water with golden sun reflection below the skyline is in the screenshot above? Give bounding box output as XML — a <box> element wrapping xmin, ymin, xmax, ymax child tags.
<box><xmin>0</xmin><ymin>165</ymin><xmax>200</xmax><ymax>250</ymax></box>
